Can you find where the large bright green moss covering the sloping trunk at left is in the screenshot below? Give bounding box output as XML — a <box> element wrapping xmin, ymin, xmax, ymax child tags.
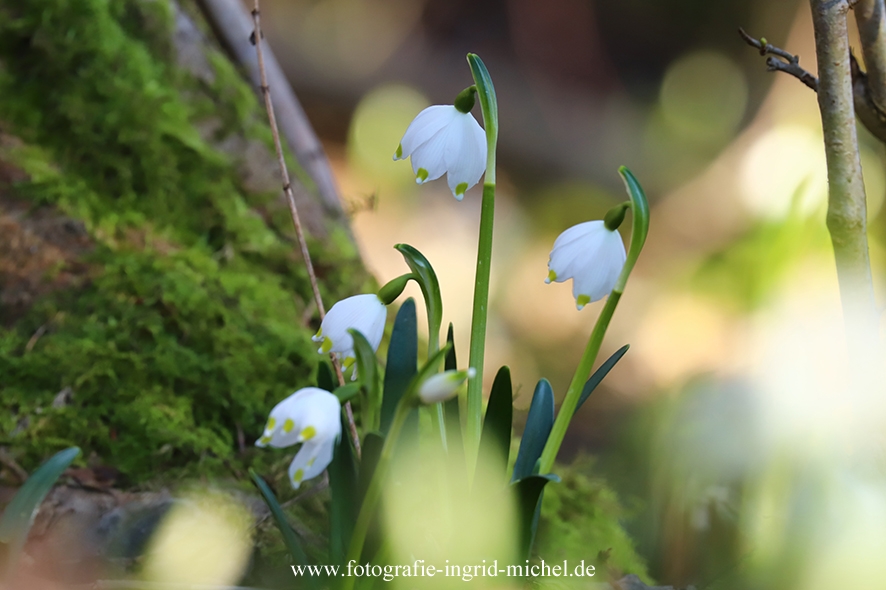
<box><xmin>0</xmin><ymin>0</ymin><xmax>368</xmax><ymax>482</ymax></box>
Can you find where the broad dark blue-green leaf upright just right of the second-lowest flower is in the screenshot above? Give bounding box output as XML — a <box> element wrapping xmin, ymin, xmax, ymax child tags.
<box><xmin>381</xmin><ymin>298</ymin><xmax>418</xmax><ymax>434</ymax></box>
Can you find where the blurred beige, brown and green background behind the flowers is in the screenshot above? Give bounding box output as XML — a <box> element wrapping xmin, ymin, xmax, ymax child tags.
<box><xmin>251</xmin><ymin>0</ymin><xmax>886</xmax><ymax>588</ymax></box>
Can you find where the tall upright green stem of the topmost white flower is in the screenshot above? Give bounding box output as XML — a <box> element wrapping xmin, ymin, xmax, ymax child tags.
<box><xmin>464</xmin><ymin>53</ymin><xmax>498</xmax><ymax>477</ymax></box>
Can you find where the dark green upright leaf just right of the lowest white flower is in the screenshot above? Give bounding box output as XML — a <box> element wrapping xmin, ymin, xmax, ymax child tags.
<box><xmin>328</xmin><ymin>419</ymin><xmax>359</xmax><ymax>564</ymax></box>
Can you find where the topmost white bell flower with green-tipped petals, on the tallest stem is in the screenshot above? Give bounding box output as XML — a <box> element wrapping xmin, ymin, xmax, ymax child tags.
<box><xmin>394</xmin><ymin>105</ymin><xmax>486</xmax><ymax>201</ymax></box>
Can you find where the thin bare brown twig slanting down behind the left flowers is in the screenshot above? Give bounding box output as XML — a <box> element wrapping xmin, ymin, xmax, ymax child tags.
<box><xmin>252</xmin><ymin>0</ymin><xmax>360</xmax><ymax>457</ymax></box>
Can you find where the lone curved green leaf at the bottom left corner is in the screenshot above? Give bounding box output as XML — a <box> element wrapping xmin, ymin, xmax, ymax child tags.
<box><xmin>0</xmin><ymin>447</ymin><xmax>80</xmax><ymax>575</ymax></box>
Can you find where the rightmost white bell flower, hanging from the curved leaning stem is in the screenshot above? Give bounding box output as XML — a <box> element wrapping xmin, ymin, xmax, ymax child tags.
<box><xmin>545</xmin><ymin>220</ymin><xmax>627</xmax><ymax>309</ymax></box>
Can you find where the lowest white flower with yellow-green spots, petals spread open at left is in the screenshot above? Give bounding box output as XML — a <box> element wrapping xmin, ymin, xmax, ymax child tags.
<box><xmin>255</xmin><ymin>387</ymin><xmax>341</xmax><ymax>489</ymax></box>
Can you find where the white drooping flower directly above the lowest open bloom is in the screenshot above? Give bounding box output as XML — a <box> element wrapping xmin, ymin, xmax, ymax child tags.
<box><xmin>311</xmin><ymin>293</ymin><xmax>388</xmax><ymax>369</ymax></box>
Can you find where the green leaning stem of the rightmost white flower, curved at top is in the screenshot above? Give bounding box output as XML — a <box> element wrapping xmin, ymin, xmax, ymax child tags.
<box><xmin>538</xmin><ymin>166</ymin><xmax>649</xmax><ymax>473</ymax></box>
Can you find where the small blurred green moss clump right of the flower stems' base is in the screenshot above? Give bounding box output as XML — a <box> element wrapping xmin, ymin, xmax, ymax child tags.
<box><xmin>535</xmin><ymin>458</ymin><xmax>648</xmax><ymax>581</ymax></box>
